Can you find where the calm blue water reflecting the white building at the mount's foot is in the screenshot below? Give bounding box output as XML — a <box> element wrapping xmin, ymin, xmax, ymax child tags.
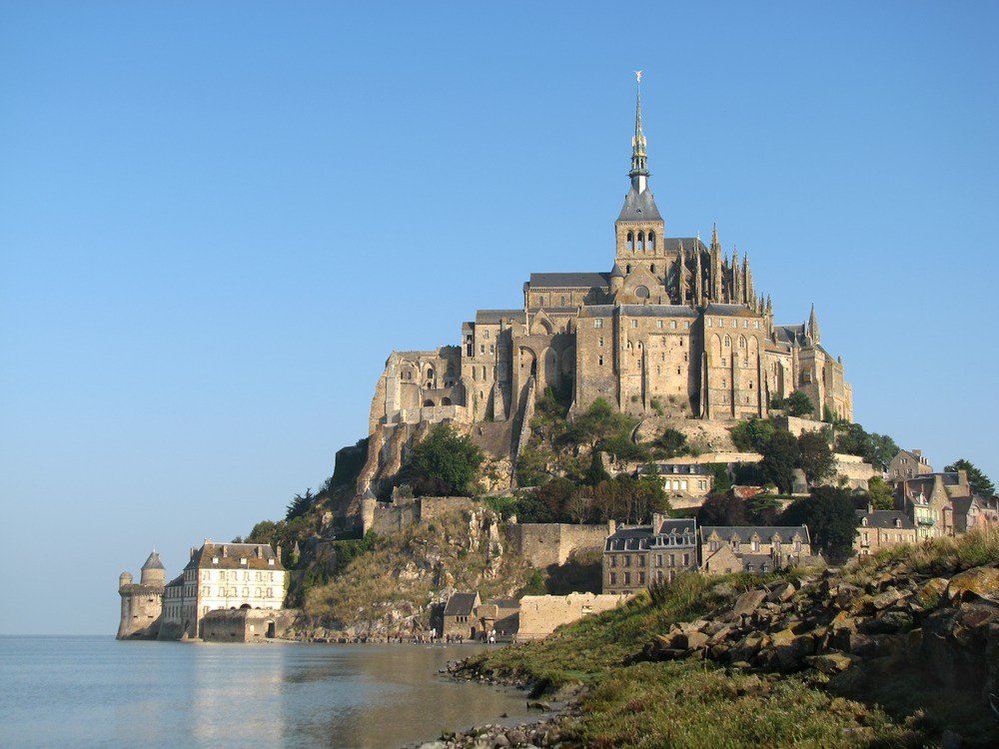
<box><xmin>0</xmin><ymin>637</ymin><xmax>525</xmax><ymax>747</ymax></box>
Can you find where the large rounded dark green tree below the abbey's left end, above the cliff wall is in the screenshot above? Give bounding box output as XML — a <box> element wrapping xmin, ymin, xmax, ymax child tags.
<box><xmin>401</xmin><ymin>424</ymin><xmax>482</xmax><ymax>496</ymax></box>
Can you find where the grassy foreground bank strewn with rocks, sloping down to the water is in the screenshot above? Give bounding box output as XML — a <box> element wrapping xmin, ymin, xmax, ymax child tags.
<box><xmin>455</xmin><ymin>530</ymin><xmax>999</xmax><ymax>747</ymax></box>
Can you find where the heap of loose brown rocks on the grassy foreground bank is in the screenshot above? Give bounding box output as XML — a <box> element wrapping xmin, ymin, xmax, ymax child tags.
<box><xmin>640</xmin><ymin>562</ymin><xmax>999</xmax><ymax>705</ymax></box>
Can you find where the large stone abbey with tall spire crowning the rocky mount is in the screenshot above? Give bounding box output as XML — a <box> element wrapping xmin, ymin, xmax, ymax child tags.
<box><xmin>359</xmin><ymin>83</ymin><xmax>853</xmax><ymax>491</ymax></box>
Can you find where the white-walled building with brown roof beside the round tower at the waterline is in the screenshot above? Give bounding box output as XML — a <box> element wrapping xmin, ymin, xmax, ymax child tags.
<box><xmin>160</xmin><ymin>540</ymin><xmax>287</xmax><ymax>639</ymax></box>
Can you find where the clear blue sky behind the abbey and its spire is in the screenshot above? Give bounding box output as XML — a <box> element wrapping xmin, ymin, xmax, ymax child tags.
<box><xmin>0</xmin><ymin>2</ymin><xmax>999</xmax><ymax>633</ymax></box>
